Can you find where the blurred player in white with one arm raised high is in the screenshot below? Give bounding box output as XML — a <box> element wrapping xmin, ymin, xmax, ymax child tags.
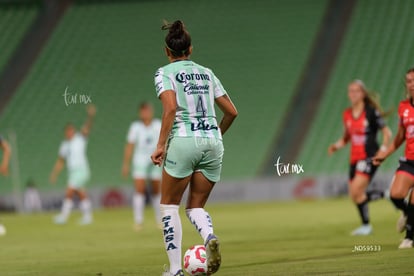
<box><xmin>50</xmin><ymin>105</ymin><xmax>96</xmax><ymax>224</ymax></box>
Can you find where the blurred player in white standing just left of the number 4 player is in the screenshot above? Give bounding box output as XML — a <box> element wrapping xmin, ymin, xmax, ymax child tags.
<box><xmin>122</xmin><ymin>102</ymin><xmax>162</xmax><ymax>230</ymax></box>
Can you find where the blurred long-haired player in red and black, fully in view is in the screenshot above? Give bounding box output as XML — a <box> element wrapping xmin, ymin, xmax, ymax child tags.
<box><xmin>328</xmin><ymin>80</ymin><xmax>391</xmax><ymax>235</ymax></box>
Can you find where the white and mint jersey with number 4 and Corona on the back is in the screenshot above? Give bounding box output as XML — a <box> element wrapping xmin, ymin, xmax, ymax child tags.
<box><xmin>155</xmin><ymin>60</ymin><xmax>227</xmax><ymax>139</ymax></box>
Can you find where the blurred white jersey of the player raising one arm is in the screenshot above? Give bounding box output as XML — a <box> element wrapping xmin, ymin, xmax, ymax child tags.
<box><xmin>59</xmin><ymin>133</ymin><xmax>89</xmax><ymax>171</ymax></box>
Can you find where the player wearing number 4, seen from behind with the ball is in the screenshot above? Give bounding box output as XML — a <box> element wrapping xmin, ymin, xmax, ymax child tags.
<box><xmin>151</xmin><ymin>20</ymin><xmax>237</xmax><ymax>276</ymax></box>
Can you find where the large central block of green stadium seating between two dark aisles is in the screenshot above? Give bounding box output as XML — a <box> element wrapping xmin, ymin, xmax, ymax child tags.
<box><xmin>0</xmin><ymin>0</ymin><xmax>327</xmax><ymax>192</ymax></box>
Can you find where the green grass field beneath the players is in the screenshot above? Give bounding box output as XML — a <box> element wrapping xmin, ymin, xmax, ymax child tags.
<box><xmin>0</xmin><ymin>199</ymin><xmax>414</xmax><ymax>276</ymax></box>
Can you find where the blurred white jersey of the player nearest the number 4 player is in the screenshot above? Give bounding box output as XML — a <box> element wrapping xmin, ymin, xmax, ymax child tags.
<box><xmin>127</xmin><ymin>119</ymin><xmax>161</xmax><ymax>164</ymax></box>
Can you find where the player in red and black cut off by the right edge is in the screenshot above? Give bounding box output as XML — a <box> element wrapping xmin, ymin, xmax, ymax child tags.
<box><xmin>374</xmin><ymin>68</ymin><xmax>414</xmax><ymax>249</ymax></box>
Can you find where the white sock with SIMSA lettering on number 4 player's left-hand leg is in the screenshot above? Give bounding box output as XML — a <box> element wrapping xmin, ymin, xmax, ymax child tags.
<box><xmin>160</xmin><ymin>204</ymin><xmax>182</xmax><ymax>274</ymax></box>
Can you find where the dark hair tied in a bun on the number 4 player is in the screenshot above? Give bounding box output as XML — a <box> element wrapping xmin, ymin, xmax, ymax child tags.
<box><xmin>161</xmin><ymin>20</ymin><xmax>191</xmax><ymax>57</ymax></box>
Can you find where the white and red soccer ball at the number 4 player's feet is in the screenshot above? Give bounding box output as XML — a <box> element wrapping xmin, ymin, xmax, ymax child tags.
<box><xmin>184</xmin><ymin>245</ymin><xmax>207</xmax><ymax>276</ymax></box>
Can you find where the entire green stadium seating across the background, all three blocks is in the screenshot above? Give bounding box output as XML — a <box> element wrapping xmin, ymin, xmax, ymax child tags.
<box><xmin>0</xmin><ymin>0</ymin><xmax>414</xmax><ymax>194</ymax></box>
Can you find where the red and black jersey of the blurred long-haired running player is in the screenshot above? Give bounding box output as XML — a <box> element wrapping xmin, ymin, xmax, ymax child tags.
<box><xmin>343</xmin><ymin>105</ymin><xmax>384</xmax><ymax>164</ymax></box>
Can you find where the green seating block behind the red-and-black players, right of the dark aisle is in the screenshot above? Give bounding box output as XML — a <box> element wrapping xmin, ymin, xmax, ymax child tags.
<box><xmin>297</xmin><ymin>0</ymin><xmax>414</xmax><ymax>175</ymax></box>
